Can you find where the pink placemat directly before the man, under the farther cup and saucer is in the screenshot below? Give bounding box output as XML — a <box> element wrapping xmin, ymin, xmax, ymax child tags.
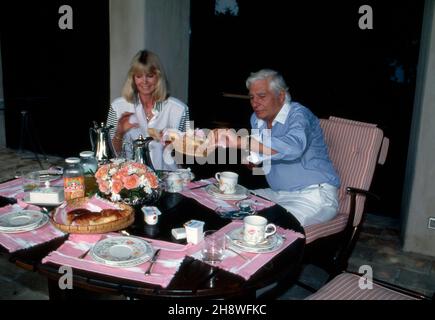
<box><xmin>181</xmin><ymin>178</ymin><xmax>275</xmax><ymax>211</ymax></box>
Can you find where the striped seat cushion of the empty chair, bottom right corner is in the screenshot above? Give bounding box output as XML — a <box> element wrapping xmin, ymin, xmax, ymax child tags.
<box><xmin>306</xmin><ymin>272</ymin><xmax>417</xmax><ymax>300</ymax></box>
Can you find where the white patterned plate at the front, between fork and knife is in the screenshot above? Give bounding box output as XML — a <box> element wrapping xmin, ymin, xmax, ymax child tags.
<box><xmin>91</xmin><ymin>236</ymin><xmax>154</xmax><ymax>268</ymax></box>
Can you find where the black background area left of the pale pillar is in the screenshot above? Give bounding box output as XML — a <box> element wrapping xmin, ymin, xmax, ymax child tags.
<box><xmin>0</xmin><ymin>0</ymin><xmax>110</xmax><ymax>157</ymax></box>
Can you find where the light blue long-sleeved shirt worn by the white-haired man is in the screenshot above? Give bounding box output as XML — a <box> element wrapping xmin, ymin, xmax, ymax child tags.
<box><xmin>251</xmin><ymin>102</ymin><xmax>340</xmax><ymax>191</ymax></box>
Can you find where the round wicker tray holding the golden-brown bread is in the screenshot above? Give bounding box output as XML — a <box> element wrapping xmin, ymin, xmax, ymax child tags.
<box><xmin>50</xmin><ymin>197</ymin><xmax>134</xmax><ymax>233</ymax></box>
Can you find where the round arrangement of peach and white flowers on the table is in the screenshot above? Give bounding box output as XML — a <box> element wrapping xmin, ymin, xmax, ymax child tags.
<box><xmin>95</xmin><ymin>161</ymin><xmax>161</xmax><ymax>205</ymax></box>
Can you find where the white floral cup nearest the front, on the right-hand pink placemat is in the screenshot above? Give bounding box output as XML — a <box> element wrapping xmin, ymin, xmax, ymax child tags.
<box><xmin>243</xmin><ymin>216</ymin><xmax>276</xmax><ymax>244</ymax></box>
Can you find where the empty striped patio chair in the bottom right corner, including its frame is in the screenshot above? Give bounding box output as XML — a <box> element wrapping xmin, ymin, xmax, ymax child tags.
<box><xmin>305</xmin><ymin>272</ymin><xmax>433</xmax><ymax>300</ymax></box>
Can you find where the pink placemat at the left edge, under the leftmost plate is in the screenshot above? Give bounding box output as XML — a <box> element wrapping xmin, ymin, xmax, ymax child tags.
<box><xmin>0</xmin><ymin>200</ymin><xmax>65</xmax><ymax>253</ymax></box>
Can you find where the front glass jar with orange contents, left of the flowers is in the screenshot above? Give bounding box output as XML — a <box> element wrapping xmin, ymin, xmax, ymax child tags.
<box><xmin>63</xmin><ymin>157</ymin><xmax>85</xmax><ymax>200</ymax></box>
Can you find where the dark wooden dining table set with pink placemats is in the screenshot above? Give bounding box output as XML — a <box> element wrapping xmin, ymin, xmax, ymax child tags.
<box><xmin>0</xmin><ymin>175</ymin><xmax>305</xmax><ymax>300</ymax></box>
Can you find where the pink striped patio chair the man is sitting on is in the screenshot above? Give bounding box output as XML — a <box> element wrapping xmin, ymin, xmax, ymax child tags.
<box><xmin>304</xmin><ymin>117</ymin><xmax>389</xmax><ymax>279</ymax></box>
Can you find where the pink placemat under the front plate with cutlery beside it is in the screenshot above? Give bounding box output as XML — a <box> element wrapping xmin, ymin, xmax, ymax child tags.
<box><xmin>42</xmin><ymin>233</ymin><xmax>188</xmax><ymax>288</ymax></box>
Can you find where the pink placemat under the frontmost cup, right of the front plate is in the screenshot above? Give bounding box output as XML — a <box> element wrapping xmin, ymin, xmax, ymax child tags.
<box><xmin>188</xmin><ymin>221</ymin><xmax>304</xmax><ymax>280</ymax></box>
